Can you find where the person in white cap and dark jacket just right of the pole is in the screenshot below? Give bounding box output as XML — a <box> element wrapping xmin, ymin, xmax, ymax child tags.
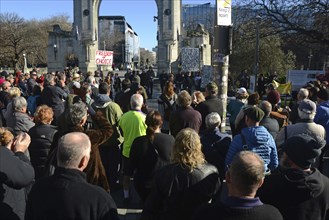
<box><xmin>227</xmin><ymin>87</ymin><xmax>249</xmax><ymax>137</ymax></box>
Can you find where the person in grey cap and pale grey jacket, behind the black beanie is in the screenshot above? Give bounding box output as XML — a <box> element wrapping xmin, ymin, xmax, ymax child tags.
<box><xmin>275</xmin><ymin>99</ymin><xmax>326</xmax><ymax>148</ymax></box>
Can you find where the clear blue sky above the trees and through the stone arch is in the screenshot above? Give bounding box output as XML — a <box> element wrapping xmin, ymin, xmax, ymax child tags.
<box><xmin>0</xmin><ymin>0</ymin><xmax>215</xmax><ymax>49</ymax></box>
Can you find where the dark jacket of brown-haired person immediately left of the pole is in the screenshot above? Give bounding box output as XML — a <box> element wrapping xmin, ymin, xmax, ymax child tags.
<box><xmin>195</xmin><ymin>95</ymin><xmax>223</xmax><ymax>131</ymax></box>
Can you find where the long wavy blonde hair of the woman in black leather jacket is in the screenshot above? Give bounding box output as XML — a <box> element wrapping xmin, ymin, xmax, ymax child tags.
<box><xmin>172</xmin><ymin>128</ymin><xmax>205</xmax><ymax>171</ymax></box>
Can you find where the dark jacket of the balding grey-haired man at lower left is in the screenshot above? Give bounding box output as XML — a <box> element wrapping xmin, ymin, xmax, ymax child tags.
<box><xmin>25</xmin><ymin>168</ymin><xmax>118</xmax><ymax>220</ymax></box>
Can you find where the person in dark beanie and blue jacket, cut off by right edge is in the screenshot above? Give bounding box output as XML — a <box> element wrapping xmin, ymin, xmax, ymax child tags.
<box><xmin>314</xmin><ymin>88</ymin><xmax>329</xmax><ymax>143</ymax></box>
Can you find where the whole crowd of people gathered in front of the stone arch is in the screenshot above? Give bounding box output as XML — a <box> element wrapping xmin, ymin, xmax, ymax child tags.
<box><xmin>0</xmin><ymin>68</ymin><xmax>329</xmax><ymax>220</ymax></box>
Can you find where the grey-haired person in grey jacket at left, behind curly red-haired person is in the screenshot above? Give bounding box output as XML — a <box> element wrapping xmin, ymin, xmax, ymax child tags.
<box><xmin>7</xmin><ymin>96</ymin><xmax>35</xmax><ymax>135</ymax></box>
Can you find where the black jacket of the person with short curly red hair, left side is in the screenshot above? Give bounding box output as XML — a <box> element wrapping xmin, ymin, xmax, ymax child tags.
<box><xmin>28</xmin><ymin>124</ymin><xmax>57</xmax><ymax>179</ymax></box>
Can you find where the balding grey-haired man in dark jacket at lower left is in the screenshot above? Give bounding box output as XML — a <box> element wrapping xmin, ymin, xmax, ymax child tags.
<box><xmin>25</xmin><ymin>132</ymin><xmax>118</xmax><ymax>220</ymax></box>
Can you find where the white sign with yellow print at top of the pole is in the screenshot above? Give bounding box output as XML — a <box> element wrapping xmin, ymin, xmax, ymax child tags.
<box><xmin>217</xmin><ymin>0</ymin><xmax>232</xmax><ymax>26</ymax></box>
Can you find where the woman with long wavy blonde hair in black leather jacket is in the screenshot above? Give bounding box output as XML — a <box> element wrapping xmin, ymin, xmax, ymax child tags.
<box><xmin>142</xmin><ymin>128</ymin><xmax>220</xmax><ymax>220</ymax></box>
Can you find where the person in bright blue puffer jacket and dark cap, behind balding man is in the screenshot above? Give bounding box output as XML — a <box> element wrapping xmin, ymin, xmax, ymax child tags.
<box><xmin>225</xmin><ymin>106</ymin><xmax>279</xmax><ymax>172</ymax></box>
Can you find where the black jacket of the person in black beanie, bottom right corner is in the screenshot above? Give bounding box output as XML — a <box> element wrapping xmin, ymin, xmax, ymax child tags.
<box><xmin>258</xmin><ymin>169</ymin><xmax>329</xmax><ymax>220</ymax></box>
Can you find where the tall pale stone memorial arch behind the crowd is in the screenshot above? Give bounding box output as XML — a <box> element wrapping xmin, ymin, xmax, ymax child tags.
<box><xmin>48</xmin><ymin>0</ymin><xmax>182</xmax><ymax>73</ymax></box>
